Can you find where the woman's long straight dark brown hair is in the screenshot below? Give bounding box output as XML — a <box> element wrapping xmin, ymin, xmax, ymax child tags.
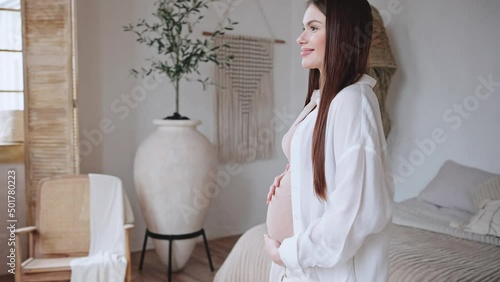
<box><xmin>305</xmin><ymin>0</ymin><xmax>373</xmax><ymax>200</ymax></box>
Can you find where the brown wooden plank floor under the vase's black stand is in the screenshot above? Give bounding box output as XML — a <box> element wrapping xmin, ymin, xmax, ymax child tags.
<box><xmin>0</xmin><ymin>235</ymin><xmax>240</xmax><ymax>282</ymax></box>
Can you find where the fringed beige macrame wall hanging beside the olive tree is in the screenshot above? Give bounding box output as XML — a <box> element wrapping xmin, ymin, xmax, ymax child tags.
<box><xmin>203</xmin><ymin>0</ymin><xmax>285</xmax><ymax>163</ymax></box>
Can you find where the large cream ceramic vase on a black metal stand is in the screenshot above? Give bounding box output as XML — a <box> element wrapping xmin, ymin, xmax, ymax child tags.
<box><xmin>134</xmin><ymin>120</ymin><xmax>217</xmax><ymax>271</ymax></box>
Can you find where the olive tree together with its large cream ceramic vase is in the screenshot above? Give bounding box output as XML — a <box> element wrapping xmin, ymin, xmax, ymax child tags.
<box><xmin>124</xmin><ymin>0</ymin><xmax>237</xmax><ymax>271</ymax></box>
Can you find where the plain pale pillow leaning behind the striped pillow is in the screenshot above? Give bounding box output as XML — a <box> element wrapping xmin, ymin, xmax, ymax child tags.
<box><xmin>417</xmin><ymin>160</ymin><xmax>496</xmax><ymax>214</ymax></box>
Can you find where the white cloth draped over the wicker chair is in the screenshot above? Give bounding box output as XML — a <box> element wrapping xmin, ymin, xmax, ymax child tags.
<box><xmin>70</xmin><ymin>174</ymin><xmax>133</xmax><ymax>282</ymax></box>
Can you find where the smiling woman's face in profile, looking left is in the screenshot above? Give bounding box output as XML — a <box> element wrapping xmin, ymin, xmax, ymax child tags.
<box><xmin>297</xmin><ymin>5</ymin><xmax>326</xmax><ymax>71</ymax></box>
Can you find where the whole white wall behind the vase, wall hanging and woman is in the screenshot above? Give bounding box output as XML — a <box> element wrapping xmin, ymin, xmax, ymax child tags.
<box><xmin>78</xmin><ymin>0</ymin><xmax>500</xmax><ymax>253</ymax></box>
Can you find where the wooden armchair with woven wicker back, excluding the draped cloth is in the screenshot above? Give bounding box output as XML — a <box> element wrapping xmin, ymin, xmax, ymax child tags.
<box><xmin>15</xmin><ymin>175</ymin><xmax>134</xmax><ymax>282</ymax></box>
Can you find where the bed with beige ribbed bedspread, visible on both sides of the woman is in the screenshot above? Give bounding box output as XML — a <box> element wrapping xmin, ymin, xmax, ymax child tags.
<box><xmin>214</xmin><ymin>198</ymin><xmax>500</xmax><ymax>282</ymax></box>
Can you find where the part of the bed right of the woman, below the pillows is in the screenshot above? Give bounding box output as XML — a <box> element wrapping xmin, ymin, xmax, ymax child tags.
<box><xmin>389</xmin><ymin>198</ymin><xmax>500</xmax><ymax>282</ymax></box>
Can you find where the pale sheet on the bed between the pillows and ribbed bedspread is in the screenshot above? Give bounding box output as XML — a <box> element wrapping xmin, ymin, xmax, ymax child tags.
<box><xmin>393</xmin><ymin>198</ymin><xmax>500</xmax><ymax>246</ymax></box>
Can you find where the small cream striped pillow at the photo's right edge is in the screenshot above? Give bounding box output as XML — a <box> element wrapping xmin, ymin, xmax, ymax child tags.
<box><xmin>465</xmin><ymin>199</ymin><xmax>500</xmax><ymax>237</ymax></box>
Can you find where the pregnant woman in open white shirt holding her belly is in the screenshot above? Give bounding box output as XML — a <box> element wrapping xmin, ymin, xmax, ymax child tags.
<box><xmin>265</xmin><ymin>0</ymin><xmax>394</xmax><ymax>282</ymax></box>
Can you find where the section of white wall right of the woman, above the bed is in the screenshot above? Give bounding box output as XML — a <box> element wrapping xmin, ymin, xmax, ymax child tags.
<box><xmin>371</xmin><ymin>0</ymin><xmax>500</xmax><ymax>201</ymax></box>
